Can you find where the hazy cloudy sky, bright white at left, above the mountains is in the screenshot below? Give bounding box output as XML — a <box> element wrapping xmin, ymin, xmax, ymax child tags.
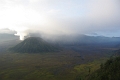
<box><xmin>0</xmin><ymin>0</ymin><xmax>120</xmax><ymax>39</ymax></box>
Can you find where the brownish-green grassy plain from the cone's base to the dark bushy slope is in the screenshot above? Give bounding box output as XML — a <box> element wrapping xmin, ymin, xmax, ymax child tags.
<box><xmin>0</xmin><ymin>51</ymin><xmax>109</xmax><ymax>80</ymax></box>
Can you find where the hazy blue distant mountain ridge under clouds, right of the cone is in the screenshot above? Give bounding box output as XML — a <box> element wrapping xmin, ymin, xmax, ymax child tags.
<box><xmin>46</xmin><ymin>35</ymin><xmax>120</xmax><ymax>45</ymax></box>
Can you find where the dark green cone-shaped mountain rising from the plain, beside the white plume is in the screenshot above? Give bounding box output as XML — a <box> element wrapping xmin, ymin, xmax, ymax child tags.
<box><xmin>10</xmin><ymin>37</ymin><xmax>59</xmax><ymax>53</ymax></box>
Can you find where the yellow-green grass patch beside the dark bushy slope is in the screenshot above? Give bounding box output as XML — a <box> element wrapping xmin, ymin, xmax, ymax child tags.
<box><xmin>74</xmin><ymin>58</ymin><xmax>108</xmax><ymax>80</ymax></box>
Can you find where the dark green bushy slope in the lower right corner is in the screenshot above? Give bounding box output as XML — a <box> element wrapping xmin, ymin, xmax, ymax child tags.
<box><xmin>88</xmin><ymin>57</ymin><xmax>120</xmax><ymax>80</ymax></box>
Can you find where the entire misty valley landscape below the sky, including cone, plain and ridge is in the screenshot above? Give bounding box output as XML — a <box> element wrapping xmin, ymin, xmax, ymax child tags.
<box><xmin>0</xmin><ymin>34</ymin><xmax>120</xmax><ymax>80</ymax></box>
